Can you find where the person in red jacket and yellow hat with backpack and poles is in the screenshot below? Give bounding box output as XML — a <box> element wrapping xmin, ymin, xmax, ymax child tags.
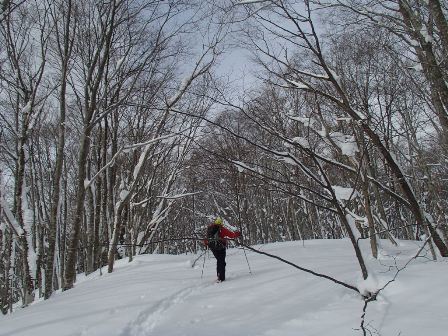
<box><xmin>204</xmin><ymin>217</ymin><xmax>241</xmax><ymax>282</ymax></box>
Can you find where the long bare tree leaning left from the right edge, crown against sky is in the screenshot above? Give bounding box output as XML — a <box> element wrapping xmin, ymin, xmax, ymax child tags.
<box><xmin>233</xmin><ymin>1</ymin><xmax>448</xmax><ymax>256</ymax></box>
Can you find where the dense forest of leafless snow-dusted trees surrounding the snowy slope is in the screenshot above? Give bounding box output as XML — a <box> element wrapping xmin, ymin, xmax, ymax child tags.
<box><xmin>0</xmin><ymin>0</ymin><xmax>448</xmax><ymax>314</ymax></box>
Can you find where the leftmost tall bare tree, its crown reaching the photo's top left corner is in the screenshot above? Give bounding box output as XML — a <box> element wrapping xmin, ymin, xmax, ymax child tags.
<box><xmin>0</xmin><ymin>0</ymin><xmax>48</xmax><ymax>305</ymax></box>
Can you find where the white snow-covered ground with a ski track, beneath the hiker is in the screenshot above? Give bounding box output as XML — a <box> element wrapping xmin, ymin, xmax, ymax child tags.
<box><xmin>0</xmin><ymin>240</ymin><xmax>448</xmax><ymax>336</ymax></box>
